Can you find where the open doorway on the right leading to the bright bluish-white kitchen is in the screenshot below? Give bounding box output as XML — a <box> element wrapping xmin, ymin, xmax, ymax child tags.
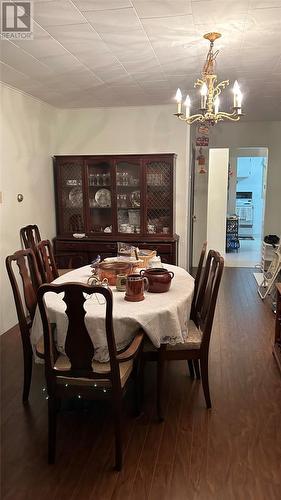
<box><xmin>225</xmin><ymin>148</ymin><xmax>268</xmax><ymax>267</ymax></box>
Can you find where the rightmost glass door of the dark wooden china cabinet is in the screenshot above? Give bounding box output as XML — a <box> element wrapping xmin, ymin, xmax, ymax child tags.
<box><xmin>145</xmin><ymin>160</ymin><xmax>173</xmax><ymax>235</ymax></box>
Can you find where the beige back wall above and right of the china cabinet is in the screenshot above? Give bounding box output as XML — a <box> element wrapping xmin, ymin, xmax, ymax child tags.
<box><xmin>55</xmin><ymin>106</ymin><xmax>190</xmax><ymax>267</ymax></box>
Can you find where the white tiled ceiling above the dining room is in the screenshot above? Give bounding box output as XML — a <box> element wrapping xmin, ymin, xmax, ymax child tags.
<box><xmin>0</xmin><ymin>0</ymin><xmax>281</xmax><ymax>120</ymax></box>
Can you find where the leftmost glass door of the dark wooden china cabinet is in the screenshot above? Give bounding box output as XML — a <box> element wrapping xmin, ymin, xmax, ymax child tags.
<box><xmin>59</xmin><ymin>159</ymin><xmax>85</xmax><ymax>234</ymax></box>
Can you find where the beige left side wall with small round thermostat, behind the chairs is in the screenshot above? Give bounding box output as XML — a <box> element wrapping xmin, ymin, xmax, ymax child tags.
<box><xmin>0</xmin><ymin>86</ymin><xmax>56</xmax><ymax>333</ymax></box>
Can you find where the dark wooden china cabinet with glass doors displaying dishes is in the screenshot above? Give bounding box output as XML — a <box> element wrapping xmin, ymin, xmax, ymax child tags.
<box><xmin>54</xmin><ymin>154</ymin><xmax>178</xmax><ymax>264</ymax></box>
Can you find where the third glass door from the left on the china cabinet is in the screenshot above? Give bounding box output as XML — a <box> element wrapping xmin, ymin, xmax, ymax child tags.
<box><xmin>116</xmin><ymin>160</ymin><xmax>141</xmax><ymax>234</ymax></box>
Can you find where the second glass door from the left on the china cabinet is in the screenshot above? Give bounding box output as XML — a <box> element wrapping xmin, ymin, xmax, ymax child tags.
<box><xmin>87</xmin><ymin>159</ymin><xmax>113</xmax><ymax>234</ymax></box>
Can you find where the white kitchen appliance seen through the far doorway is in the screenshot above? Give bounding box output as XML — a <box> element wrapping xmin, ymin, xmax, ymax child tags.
<box><xmin>236</xmin><ymin>191</ymin><xmax>254</xmax><ymax>238</ymax></box>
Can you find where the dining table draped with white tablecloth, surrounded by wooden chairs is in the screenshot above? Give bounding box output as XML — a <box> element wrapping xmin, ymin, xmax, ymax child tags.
<box><xmin>31</xmin><ymin>264</ymin><xmax>194</xmax><ymax>362</ymax></box>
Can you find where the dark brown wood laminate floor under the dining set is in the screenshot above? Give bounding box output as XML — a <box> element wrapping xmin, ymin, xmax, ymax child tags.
<box><xmin>1</xmin><ymin>268</ymin><xmax>281</xmax><ymax>500</ymax></box>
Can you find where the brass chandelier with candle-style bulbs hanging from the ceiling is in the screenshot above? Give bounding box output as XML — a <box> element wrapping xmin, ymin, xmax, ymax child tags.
<box><xmin>175</xmin><ymin>32</ymin><xmax>242</xmax><ymax>125</ymax></box>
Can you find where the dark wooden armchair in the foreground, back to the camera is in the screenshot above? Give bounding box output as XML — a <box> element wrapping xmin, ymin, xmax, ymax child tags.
<box><xmin>38</xmin><ymin>283</ymin><xmax>143</xmax><ymax>470</ymax></box>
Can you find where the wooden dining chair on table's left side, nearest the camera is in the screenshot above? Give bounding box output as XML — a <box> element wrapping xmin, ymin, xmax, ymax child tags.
<box><xmin>6</xmin><ymin>248</ymin><xmax>43</xmax><ymax>402</ymax></box>
